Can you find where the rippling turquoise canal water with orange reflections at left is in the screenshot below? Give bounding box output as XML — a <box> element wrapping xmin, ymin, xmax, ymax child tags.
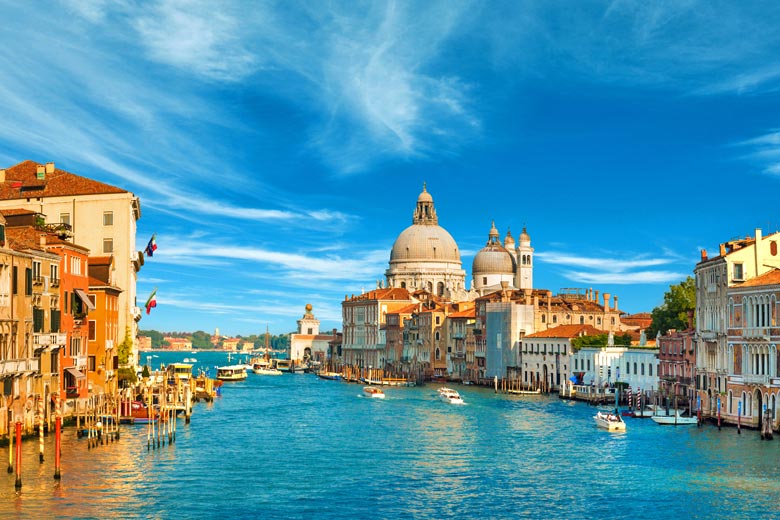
<box><xmin>0</xmin><ymin>353</ymin><xmax>780</xmax><ymax>519</ymax></box>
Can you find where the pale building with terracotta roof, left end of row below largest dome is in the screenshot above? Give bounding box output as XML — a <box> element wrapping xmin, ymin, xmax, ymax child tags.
<box><xmin>341</xmin><ymin>287</ymin><xmax>415</xmax><ymax>368</ymax></box>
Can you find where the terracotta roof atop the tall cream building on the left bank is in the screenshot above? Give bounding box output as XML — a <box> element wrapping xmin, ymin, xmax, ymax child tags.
<box><xmin>0</xmin><ymin>161</ymin><xmax>128</xmax><ymax>200</ymax></box>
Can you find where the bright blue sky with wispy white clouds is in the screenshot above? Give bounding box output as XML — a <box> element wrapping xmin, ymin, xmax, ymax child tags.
<box><xmin>0</xmin><ymin>0</ymin><xmax>780</xmax><ymax>335</ymax></box>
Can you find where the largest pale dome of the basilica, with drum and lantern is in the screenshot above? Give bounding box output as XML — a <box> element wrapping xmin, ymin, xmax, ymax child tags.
<box><xmin>386</xmin><ymin>185</ymin><xmax>468</xmax><ymax>298</ymax></box>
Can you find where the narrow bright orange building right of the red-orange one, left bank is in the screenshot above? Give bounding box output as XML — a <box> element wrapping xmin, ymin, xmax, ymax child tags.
<box><xmin>87</xmin><ymin>256</ymin><xmax>122</xmax><ymax>395</ymax></box>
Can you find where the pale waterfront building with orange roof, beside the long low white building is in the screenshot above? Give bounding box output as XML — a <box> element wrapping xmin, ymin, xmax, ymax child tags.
<box><xmin>519</xmin><ymin>325</ymin><xmax>607</xmax><ymax>392</ymax></box>
